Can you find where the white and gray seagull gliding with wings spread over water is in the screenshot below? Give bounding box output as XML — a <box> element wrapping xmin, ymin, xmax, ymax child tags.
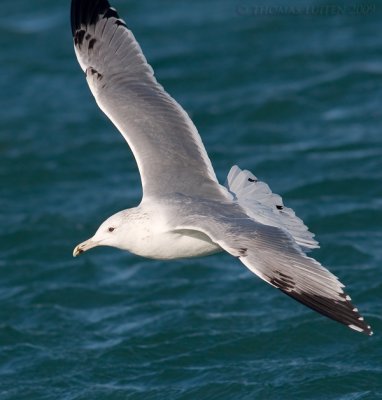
<box><xmin>71</xmin><ymin>0</ymin><xmax>373</xmax><ymax>335</ymax></box>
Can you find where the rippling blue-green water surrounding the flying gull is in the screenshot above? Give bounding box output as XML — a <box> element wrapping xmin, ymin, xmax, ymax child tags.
<box><xmin>0</xmin><ymin>0</ymin><xmax>382</xmax><ymax>400</ymax></box>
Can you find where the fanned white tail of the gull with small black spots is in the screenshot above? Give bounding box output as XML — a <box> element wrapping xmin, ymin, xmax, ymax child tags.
<box><xmin>225</xmin><ymin>165</ymin><xmax>320</xmax><ymax>250</ymax></box>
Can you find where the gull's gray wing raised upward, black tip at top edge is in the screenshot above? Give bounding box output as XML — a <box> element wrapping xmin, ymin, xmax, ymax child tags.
<box><xmin>71</xmin><ymin>0</ymin><xmax>225</xmax><ymax>197</ymax></box>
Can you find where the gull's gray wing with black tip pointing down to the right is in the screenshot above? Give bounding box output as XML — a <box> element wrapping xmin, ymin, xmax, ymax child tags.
<box><xmin>172</xmin><ymin>200</ymin><xmax>372</xmax><ymax>335</ymax></box>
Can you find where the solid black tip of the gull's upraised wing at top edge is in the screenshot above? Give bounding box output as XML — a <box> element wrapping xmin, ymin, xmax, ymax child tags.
<box><xmin>70</xmin><ymin>0</ymin><xmax>114</xmax><ymax>37</ymax></box>
